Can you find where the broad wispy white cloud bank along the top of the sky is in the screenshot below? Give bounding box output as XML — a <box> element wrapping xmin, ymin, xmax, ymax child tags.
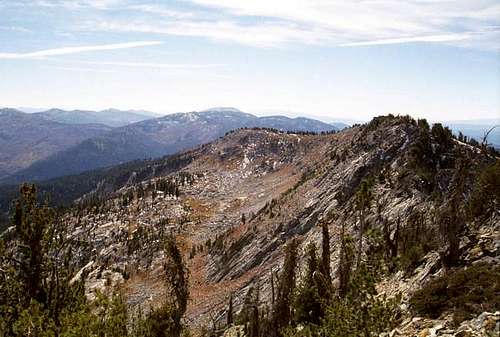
<box><xmin>4</xmin><ymin>0</ymin><xmax>500</xmax><ymax>50</ymax></box>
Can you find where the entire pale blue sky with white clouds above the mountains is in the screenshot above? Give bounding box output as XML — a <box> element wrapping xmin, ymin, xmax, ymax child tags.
<box><xmin>0</xmin><ymin>0</ymin><xmax>500</xmax><ymax>120</ymax></box>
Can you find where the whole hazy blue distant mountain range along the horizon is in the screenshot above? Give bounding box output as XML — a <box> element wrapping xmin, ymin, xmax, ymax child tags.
<box><xmin>0</xmin><ymin>107</ymin><xmax>500</xmax><ymax>184</ymax></box>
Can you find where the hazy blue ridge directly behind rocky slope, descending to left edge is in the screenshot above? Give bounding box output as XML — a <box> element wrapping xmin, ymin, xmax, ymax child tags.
<box><xmin>0</xmin><ymin>108</ymin><xmax>336</xmax><ymax>184</ymax></box>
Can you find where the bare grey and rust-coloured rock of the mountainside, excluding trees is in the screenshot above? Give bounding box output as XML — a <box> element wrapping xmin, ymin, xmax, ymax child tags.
<box><xmin>48</xmin><ymin>118</ymin><xmax>500</xmax><ymax>336</ymax></box>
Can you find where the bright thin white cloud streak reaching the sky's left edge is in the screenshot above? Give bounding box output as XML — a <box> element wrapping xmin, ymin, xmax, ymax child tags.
<box><xmin>0</xmin><ymin>41</ymin><xmax>163</xmax><ymax>59</ymax></box>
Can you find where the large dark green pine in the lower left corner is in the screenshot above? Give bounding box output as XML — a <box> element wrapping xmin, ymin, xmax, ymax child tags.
<box><xmin>0</xmin><ymin>184</ymin><xmax>85</xmax><ymax>335</ymax></box>
